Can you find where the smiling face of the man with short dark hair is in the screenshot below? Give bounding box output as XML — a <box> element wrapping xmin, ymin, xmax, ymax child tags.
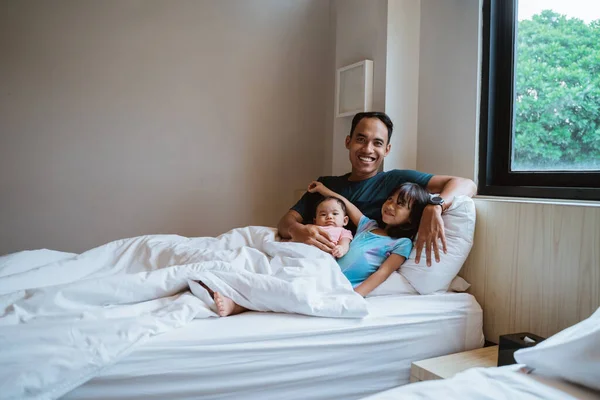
<box><xmin>346</xmin><ymin>118</ymin><xmax>391</xmax><ymax>180</ymax></box>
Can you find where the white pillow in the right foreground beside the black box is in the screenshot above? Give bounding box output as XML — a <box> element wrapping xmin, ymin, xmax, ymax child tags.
<box><xmin>515</xmin><ymin>308</ymin><xmax>600</xmax><ymax>390</ymax></box>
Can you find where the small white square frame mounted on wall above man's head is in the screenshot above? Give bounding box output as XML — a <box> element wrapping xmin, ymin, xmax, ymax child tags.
<box><xmin>335</xmin><ymin>60</ymin><xmax>373</xmax><ymax>118</ymax></box>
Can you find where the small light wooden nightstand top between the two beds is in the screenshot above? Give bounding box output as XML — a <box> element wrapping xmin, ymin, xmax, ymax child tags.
<box><xmin>410</xmin><ymin>346</ymin><xmax>498</xmax><ymax>383</ymax></box>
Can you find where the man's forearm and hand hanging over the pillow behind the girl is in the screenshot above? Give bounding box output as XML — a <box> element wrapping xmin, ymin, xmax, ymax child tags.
<box><xmin>415</xmin><ymin>175</ymin><xmax>477</xmax><ymax>267</ymax></box>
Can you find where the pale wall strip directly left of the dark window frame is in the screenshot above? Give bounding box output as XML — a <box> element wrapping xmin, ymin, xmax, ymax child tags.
<box><xmin>417</xmin><ymin>0</ymin><xmax>480</xmax><ymax>179</ymax></box>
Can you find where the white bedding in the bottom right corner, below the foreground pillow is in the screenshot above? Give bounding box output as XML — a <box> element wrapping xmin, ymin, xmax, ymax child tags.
<box><xmin>363</xmin><ymin>365</ymin><xmax>600</xmax><ymax>400</ymax></box>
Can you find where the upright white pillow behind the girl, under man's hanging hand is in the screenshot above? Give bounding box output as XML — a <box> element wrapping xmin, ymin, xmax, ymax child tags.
<box><xmin>400</xmin><ymin>196</ymin><xmax>475</xmax><ymax>294</ymax></box>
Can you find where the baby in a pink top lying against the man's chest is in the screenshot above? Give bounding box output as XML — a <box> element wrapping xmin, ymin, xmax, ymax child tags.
<box><xmin>314</xmin><ymin>197</ymin><xmax>352</xmax><ymax>258</ymax></box>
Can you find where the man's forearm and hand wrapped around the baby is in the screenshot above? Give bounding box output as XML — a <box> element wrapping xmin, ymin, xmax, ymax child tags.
<box><xmin>277</xmin><ymin>210</ymin><xmax>335</xmax><ymax>253</ymax></box>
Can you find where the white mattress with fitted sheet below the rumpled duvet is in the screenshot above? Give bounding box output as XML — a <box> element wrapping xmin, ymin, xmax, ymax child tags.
<box><xmin>65</xmin><ymin>293</ymin><xmax>483</xmax><ymax>400</ymax></box>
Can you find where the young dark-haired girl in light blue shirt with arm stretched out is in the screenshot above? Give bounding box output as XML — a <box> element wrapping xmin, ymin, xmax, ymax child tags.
<box><xmin>308</xmin><ymin>182</ymin><xmax>429</xmax><ymax>296</ymax></box>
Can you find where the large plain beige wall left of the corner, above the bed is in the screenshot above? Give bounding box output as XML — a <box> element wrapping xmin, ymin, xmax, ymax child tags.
<box><xmin>0</xmin><ymin>0</ymin><xmax>333</xmax><ymax>253</ymax></box>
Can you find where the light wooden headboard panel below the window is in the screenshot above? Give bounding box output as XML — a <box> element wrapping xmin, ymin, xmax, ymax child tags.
<box><xmin>459</xmin><ymin>198</ymin><xmax>600</xmax><ymax>343</ymax></box>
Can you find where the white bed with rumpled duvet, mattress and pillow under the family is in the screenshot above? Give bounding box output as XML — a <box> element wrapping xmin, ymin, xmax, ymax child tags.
<box><xmin>0</xmin><ymin>198</ymin><xmax>484</xmax><ymax>399</ymax></box>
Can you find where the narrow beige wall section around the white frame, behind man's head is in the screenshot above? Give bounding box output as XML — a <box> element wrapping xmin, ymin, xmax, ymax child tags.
<box><xmin>331</xmin><ymin>0</ymin><xmax>421</xmax><ymax>175</ymax></box>
